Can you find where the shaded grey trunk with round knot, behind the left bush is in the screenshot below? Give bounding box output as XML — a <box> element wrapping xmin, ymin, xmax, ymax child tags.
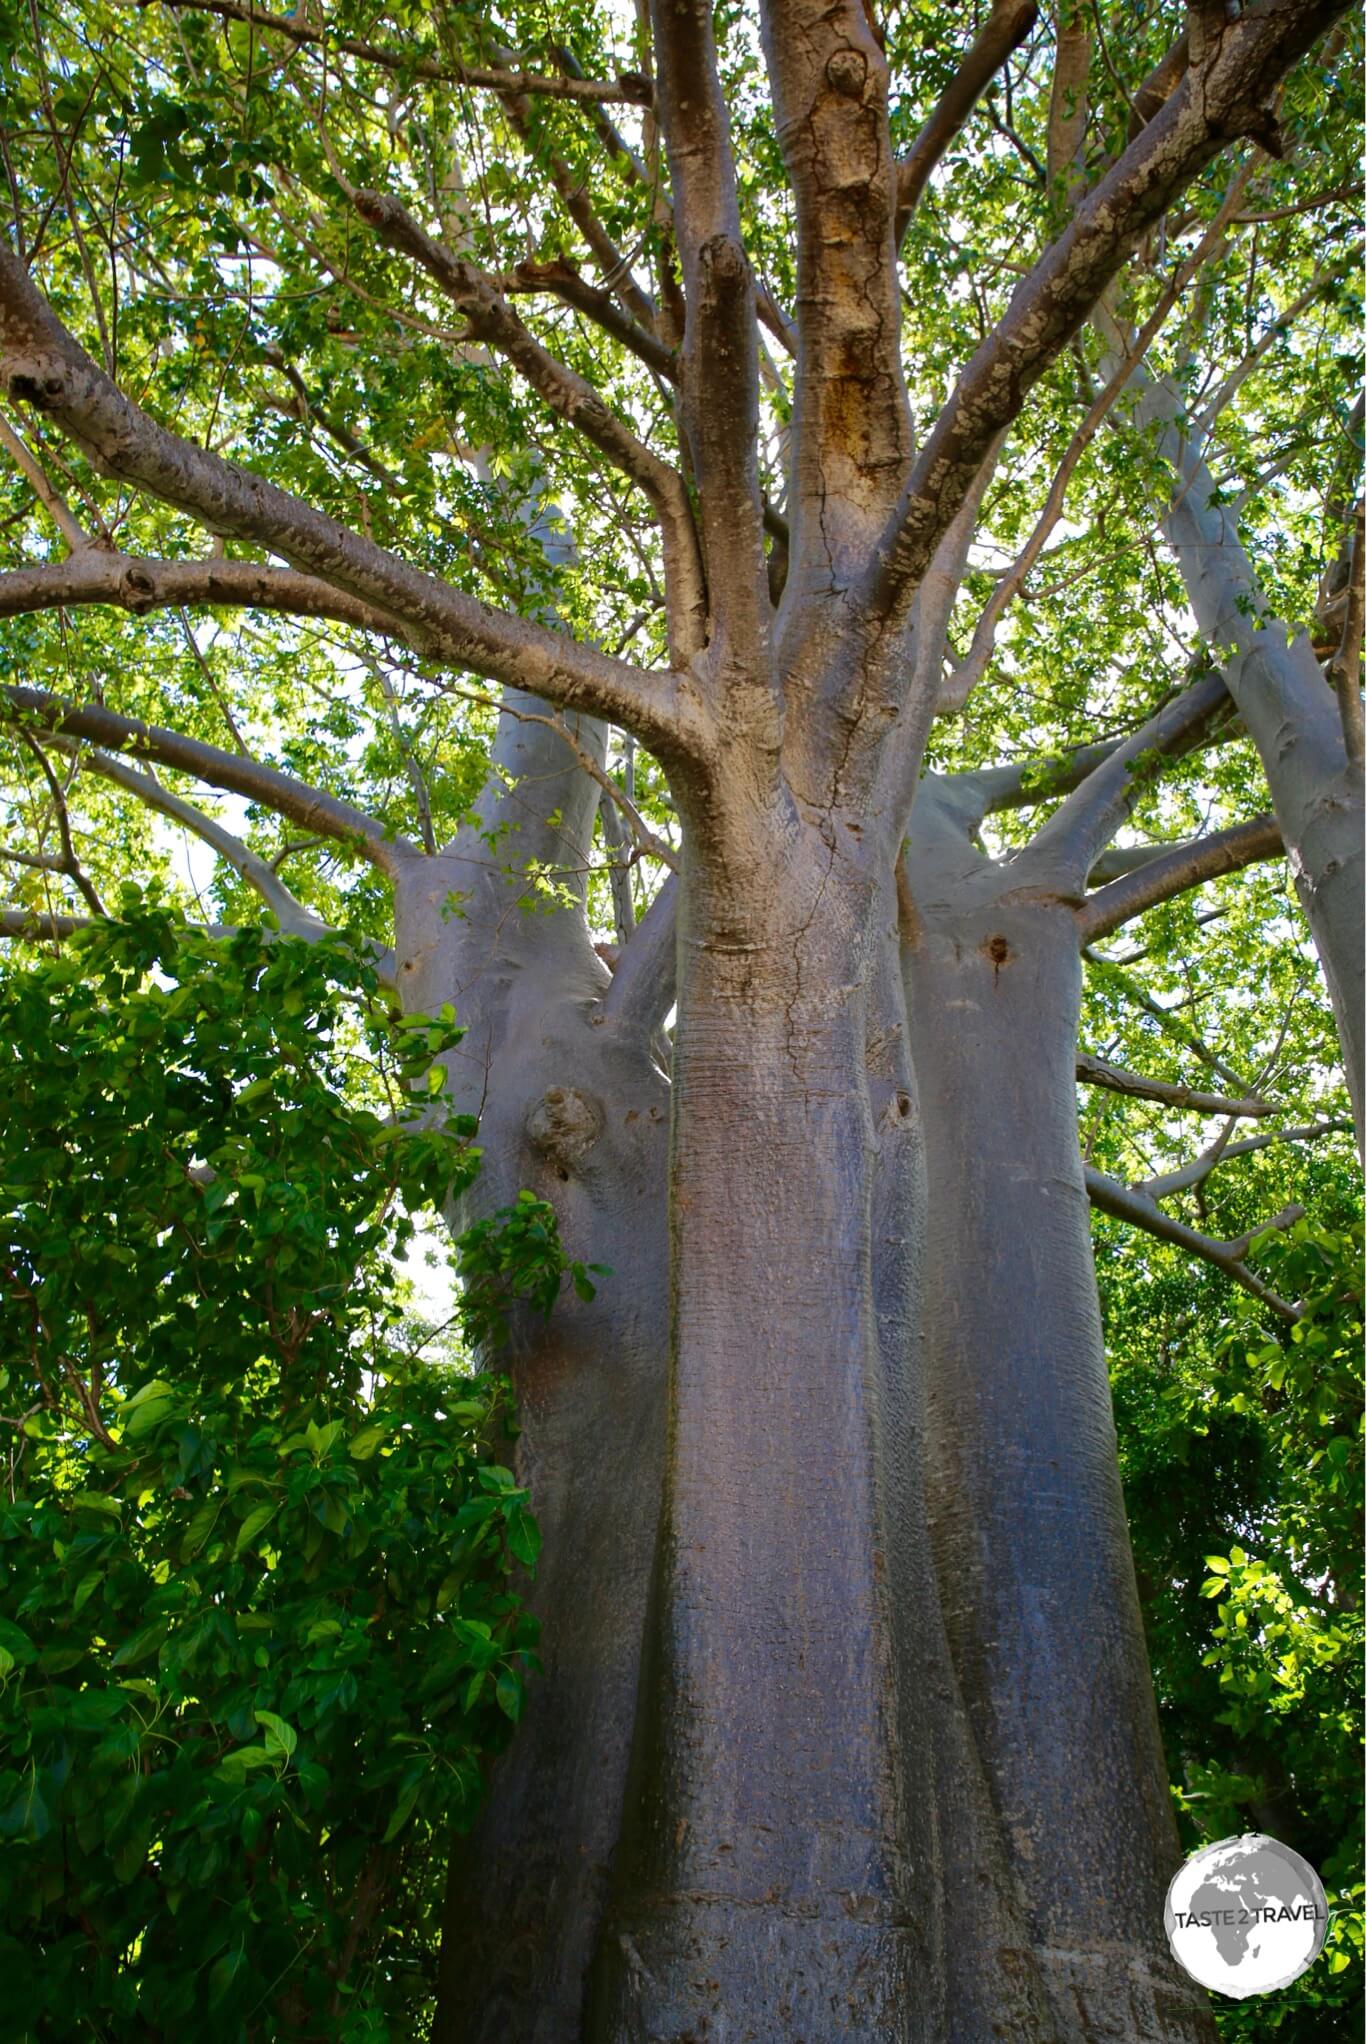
<box><xmin>395</xmin><ymin>695</ymin><xmax>669</xmax><ymax>2044</ymax></box>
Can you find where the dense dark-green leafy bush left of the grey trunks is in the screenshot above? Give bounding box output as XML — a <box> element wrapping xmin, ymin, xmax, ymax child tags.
<box><xmin>0</xmin><ymin>915</ymin><xmax>589</xmax><ymax>2044</ymax></box>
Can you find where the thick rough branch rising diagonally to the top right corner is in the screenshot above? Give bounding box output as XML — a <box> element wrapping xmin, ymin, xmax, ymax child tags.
<box><xmin>865</xmin><ymin>0</ymin><xmax>1346</xmax><ymax>628</ymax></box>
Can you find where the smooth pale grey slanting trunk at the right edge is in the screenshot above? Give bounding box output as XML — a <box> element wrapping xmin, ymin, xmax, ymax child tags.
<box><xmin>1139</xmin><ymin>365</ymin><xmax>1366</xmax><ymax>1147</ymax></box>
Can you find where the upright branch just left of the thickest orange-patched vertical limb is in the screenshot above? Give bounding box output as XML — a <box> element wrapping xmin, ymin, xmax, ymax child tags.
<box><xmin>650</xmin><ymin>0</ymin><xmax>769</xmax><ymax>683</ymax></box>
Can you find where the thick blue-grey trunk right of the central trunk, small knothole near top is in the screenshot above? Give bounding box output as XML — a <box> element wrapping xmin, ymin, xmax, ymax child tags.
<box><xmin>906</xmin><ymin>846</ymin><xmax>1213</xmax><ymax>2044</ymax></box>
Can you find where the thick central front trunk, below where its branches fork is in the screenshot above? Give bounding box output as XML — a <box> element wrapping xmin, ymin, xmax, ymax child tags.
<box><xmin>591</xmin><ymin>828</ymin><xmax>943</xmax><ymax>2044</ymax></box>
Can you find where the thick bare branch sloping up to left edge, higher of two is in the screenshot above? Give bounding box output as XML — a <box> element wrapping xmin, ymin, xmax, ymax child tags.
<box><xmin>0</xmin><ymin>245</ymin><xmax>695</xmax><ymax>758</ymax></box>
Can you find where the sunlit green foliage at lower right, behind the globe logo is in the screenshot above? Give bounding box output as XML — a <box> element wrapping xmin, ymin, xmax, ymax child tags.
<box><xmin>1102</xmin><ymin>1201</ymin><xmax>1364</xmax><ymax>2044</ymax></box>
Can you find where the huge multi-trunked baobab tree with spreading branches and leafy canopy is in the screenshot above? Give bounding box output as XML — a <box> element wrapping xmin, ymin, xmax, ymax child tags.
<box><xmin>0</xmin><ymin>0</ymin><xmax>1362</xmax><ymax>2044</ymax></box>
